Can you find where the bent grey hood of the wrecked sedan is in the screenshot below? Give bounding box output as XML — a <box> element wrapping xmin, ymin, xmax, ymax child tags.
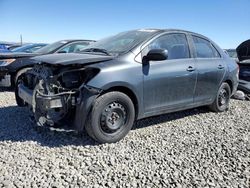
<box><xmin>31</xmin><ymin>53</ymin><xmax>114</xmax><ymax>65</ymax></box>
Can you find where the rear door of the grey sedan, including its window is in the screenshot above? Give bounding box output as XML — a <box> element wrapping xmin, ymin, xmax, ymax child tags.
<box><xmin>191</xmin><ymin>35</ymin><xmax>226</xmax><ymax>104</ymax></box>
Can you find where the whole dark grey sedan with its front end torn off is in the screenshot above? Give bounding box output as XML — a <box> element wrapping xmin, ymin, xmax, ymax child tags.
<box><xmin>16</xmin><ymin>29</ymin><xmax>238</xmax><ymax>143</ymax></box>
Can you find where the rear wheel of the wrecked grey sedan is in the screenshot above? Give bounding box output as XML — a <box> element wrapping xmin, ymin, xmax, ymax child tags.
<box><xmin>209</xmin><ymin>82</ymin><xmax>231</xmax><ymax>112</ymax></box>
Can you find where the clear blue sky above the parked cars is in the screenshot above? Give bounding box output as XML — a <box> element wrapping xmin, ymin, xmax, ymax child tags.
<box><xmin>0</xmin><ymin>0</ymin><xmax>250</xmax><ymax>48</ymax></box>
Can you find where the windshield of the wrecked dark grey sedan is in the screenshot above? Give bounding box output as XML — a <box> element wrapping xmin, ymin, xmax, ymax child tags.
<box><xmin>81</xmin><ymin>30</ymin><xmax>160</xmax><ymax>55</ymax></box>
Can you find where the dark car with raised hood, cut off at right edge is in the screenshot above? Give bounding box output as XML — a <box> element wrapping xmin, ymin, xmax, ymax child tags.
<box><xmin>236</xmin><ymin>40</ymin><xmax>250</xmax><ymax>95</ymax></box>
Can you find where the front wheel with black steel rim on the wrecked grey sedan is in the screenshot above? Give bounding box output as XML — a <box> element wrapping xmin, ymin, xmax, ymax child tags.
<box><xmin>85</xmin><ymin>91</ymin><xmax>135</xmax><ymax>143</ymax></box>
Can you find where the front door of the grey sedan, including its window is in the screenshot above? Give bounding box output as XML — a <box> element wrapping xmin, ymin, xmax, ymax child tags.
<box><xmin>143</xmin><ymin>33</ymin><xmax>196</xmax><ymax>113</ymax></box>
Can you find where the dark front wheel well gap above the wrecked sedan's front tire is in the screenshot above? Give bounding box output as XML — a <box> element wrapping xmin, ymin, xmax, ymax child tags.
<box><xmin>104</xmin><ymin>86</ymin><xmax>138</xmax><ymax>118</ymax></box>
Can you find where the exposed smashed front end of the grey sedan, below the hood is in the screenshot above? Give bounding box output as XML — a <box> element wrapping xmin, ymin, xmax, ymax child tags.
<box><xmin>18</xmin><ymin>64</ymin><xmax>101</xmax><ymax>131</ymax></box>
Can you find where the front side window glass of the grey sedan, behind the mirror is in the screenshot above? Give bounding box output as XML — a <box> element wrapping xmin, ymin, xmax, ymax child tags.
<box><xmin>147</xmin><ymin>33</ymin><xmax>190</xmax><ymax>60</ymax></box>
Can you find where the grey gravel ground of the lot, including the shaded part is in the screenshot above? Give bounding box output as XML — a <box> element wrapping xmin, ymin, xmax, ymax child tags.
<box><xmin>0</xmin><ymin>88</ymin><xmax>250</xmax><ymax>188</ymax></box>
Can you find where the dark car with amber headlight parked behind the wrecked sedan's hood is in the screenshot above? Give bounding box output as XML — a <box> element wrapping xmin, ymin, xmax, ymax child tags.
<box><xmin>0</xmin><ymin>40</ymin><xmax>94</xmax><ymax>87</ymax></box>
